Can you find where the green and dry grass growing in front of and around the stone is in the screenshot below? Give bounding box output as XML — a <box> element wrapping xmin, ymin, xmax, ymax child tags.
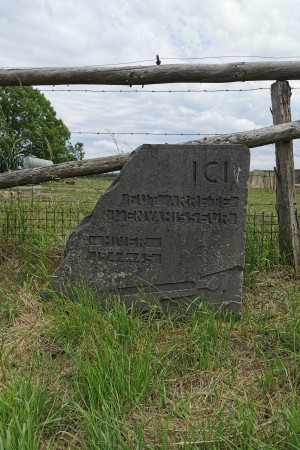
<box><xmin>0</xmin><ymin>180</ymin><xmax>300</xmax><ymax>450</ymax></box>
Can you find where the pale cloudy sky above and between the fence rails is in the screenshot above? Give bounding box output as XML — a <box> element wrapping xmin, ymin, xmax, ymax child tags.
<box><xmin>0</xmin><ymin>0</ymin><xmax>300</xmax><ymax>169</ymax></box>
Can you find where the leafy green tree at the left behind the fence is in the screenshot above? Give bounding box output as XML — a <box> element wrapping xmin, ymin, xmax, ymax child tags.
<box><xmin>0</xmin><ymin>87</ymin><xmax>84</xmax><ymax>172</ymax></box>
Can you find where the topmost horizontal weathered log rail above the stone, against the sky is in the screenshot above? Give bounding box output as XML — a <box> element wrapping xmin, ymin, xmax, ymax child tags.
<box><xmin>0</xmin><ymin>61</ymin><xmax>300</xmax><ymax>86</ymax></box>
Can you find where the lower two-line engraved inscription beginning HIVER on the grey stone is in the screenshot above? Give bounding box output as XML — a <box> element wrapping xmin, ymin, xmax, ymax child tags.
<box><xmin>89</xmin><ymin>235</ymin><xmax>161</xmax><ymax>264</ymax></box>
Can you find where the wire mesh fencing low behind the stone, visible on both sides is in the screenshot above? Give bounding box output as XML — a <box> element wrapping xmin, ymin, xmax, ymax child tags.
<box><xmin>0</xmin><ymin>199</ymin><xmax>286</xmax><ymax>266</ymax></box>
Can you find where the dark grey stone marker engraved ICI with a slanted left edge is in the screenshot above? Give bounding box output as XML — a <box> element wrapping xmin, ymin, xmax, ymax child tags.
<box><xmin>52</xmin><ymin>145</ymin><xmax>250</xmax><ymax>310</ymax></box>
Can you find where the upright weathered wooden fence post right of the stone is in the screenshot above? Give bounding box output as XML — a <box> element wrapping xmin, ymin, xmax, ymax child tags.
<box><xmin>271</xmin><ymin>81</ymin><xmax>300</xmax><ymax>274</ymax></box>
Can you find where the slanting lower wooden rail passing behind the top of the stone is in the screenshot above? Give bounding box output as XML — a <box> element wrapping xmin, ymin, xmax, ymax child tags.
<box><xmin>0</xmin><ymin>120</ymin><xmax>300</xmax><ymax>189</ymax></box>
